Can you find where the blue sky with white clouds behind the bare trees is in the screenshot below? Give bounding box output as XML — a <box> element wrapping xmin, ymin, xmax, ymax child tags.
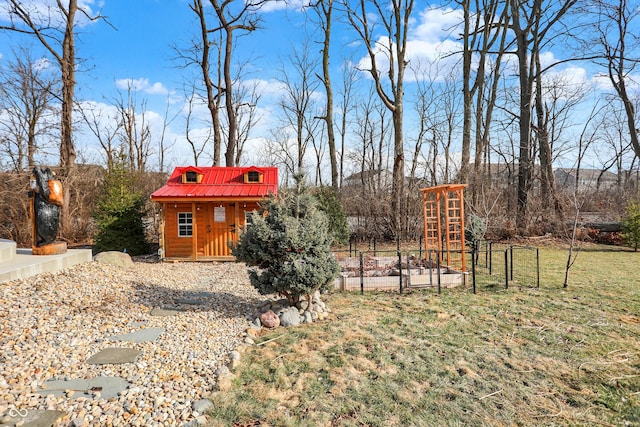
<box><xmin>0</xmin><ymin>0</ymin><xmax>636</xmax><ymax>177</ymax></box>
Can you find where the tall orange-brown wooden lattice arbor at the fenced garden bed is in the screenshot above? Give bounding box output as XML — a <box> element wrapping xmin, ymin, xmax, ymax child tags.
<box><xmin>420</xmin><ymin>184</ymin><xmax>467</xmax><ymax>271</ymax></box>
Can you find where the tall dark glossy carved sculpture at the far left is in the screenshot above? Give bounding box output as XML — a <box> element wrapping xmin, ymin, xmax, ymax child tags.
<box><xmin>29</xmin><ymin>167</ymin><xmax>61</xmax><ymax>247</ymax></box>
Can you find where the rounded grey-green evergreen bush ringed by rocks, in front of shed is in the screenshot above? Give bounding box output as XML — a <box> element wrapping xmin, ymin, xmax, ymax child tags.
<box><xmin>232</xmin><ymin>177</ymin><xmax>339</xmax><ymax>305</ymax></box>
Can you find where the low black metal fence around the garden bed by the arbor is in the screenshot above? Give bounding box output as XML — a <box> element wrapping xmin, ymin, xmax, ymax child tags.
<box><xmin>334</xmin><ymin>242</ymin><xmax>540</xmax><ymax>293</ymax></box>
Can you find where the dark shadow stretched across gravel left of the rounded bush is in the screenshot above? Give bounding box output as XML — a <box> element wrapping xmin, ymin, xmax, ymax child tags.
<box><xmin>133</xmin><ymin>282</ymin><xmax>263</xmax><ymax>317</ymax></box>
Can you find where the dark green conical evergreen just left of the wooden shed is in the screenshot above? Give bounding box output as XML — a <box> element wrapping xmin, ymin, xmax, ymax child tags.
<box><xmin>93</xmin><ymin>155</ymin><xmax>150</xmax><ymax>255</ymax></box>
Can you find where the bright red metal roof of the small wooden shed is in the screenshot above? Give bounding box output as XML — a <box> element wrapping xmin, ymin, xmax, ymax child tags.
<box><xmin>151</xmin><ymin>166</ymin><xmax>278</xmax><ymax>201</ymax></box>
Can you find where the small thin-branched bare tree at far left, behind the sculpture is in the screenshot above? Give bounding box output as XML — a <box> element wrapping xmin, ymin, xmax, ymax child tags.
<box><xmin>0</xmin><ymin>47</ymin><xmax>57</xmax><ymax>172</ymax></box>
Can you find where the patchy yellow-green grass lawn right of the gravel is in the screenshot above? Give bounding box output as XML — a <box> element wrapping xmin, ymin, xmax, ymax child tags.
<box><xmin>206</xmin><ymin>246</ymin><xmax>640</xmax><ymax>426</ymax></box>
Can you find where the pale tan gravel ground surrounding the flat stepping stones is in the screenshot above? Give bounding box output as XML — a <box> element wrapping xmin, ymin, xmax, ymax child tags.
<box><xmin>0</xmin><ymin>262</ymin><xmax>262</xmax><ymax>426</ymax></box>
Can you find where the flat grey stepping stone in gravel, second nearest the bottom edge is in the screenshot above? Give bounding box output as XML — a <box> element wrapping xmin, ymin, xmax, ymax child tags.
<box><xmin>37</xmin><ymin>377</ymin><xmax>131</xmax><ymax>399</ymax></box>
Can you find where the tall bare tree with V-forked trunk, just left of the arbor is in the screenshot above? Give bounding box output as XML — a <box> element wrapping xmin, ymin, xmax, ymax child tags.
<box><xmin>345</xmin><ymin>0</ymin><xmax>414</xmax><ymax>238</ymax></box>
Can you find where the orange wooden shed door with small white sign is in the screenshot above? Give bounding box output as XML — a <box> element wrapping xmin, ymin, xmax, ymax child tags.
<box><xmin>198</xmin><ymin>203</ymin><xmax>237</xmax><ymax>257</ymax></box>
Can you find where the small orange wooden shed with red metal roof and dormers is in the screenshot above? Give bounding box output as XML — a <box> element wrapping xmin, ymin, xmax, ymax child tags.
<box><xmin>151</xmin><ymin>166</ymin><xmax>278</xmax><ymax>260</ymax></box>
